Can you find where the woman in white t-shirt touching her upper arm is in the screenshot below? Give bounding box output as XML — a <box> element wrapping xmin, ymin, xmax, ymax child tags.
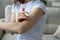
<box><xmin>0</xmin><ymin>0</ymin><xmax>45</xmax><ymax>40</ymax></box>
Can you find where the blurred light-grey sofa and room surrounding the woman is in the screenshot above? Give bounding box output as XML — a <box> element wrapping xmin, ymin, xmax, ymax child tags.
<box><xmin>0</xmin><ymin>0</ymin><xmax>60</xmax><ymax>40</ymax></box>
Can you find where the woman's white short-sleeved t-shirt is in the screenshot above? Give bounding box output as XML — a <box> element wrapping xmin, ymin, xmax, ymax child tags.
<box><xmin>12</xmin><ymin>1</ymin><xmax>45</xmax><ymax>40</ymax></box>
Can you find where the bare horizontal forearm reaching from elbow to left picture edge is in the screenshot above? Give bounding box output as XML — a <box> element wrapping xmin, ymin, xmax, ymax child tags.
<box><xmin>0</xmin><ymin>22</ymin><xmax>20</xmax><ymax>33</ymax></box>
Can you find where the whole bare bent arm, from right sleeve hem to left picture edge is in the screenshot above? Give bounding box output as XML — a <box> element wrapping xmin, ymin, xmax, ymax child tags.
<box><xmin>0</xmin><ymin>8</ymin><xmax>43</xmax><ymax>34</ymax></box>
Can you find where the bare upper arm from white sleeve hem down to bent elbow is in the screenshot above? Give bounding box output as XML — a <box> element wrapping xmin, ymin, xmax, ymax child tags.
<box><xmin>18</xmin><ymin>8</ymin><xmax>43</xmax><ymax>34</ymax></box>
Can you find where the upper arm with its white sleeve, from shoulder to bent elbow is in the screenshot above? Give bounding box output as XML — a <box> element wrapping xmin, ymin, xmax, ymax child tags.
<box><xmin>17</xmin><ymin>2</ymin><xmax>45</xmax><ymax>33</ymax></box>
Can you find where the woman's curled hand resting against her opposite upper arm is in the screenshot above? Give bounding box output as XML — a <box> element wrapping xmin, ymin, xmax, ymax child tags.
<box><xmin>18</xmin><ymin>8</ymin><xmax>29</xmax><ymax>22</ymax></box>
